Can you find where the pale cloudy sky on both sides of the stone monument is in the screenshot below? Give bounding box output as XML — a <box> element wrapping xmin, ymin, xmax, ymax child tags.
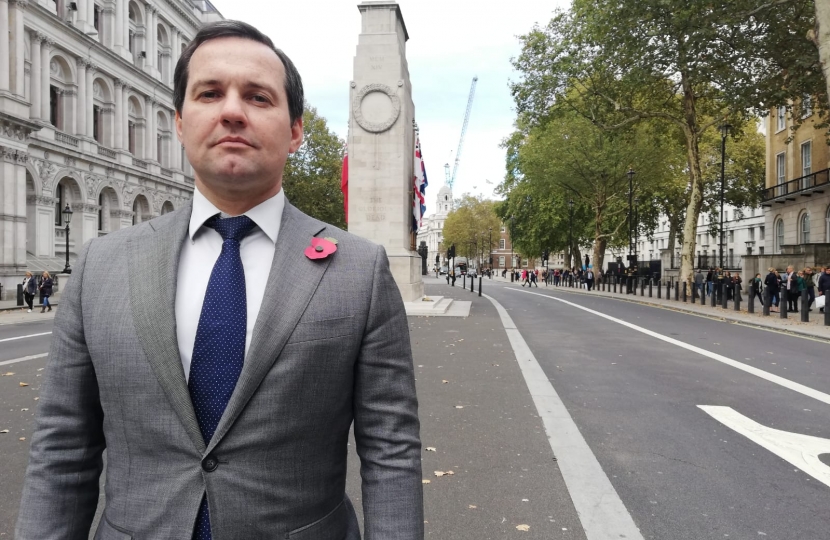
<box><xmin>211</xmin><ymin>0</ymin><xmax>568</xmax><ymax>215</ymax></box>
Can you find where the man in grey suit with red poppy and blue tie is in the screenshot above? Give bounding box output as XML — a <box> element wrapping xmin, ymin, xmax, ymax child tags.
<box><xmin>16</xmin><ymin>21</ymin><xmax>423</xmax><ymax>540</ymax></box>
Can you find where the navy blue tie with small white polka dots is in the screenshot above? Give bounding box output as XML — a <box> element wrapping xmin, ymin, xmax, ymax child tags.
<box><xmin>188</xmin><ymin>216</ymin><xmax>256</xmax><ymax>540</ymax></box>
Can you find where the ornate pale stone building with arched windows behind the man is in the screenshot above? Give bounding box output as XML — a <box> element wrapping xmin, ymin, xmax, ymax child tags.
<box><xmin>0</xmin><ymin>0</ymin><xmax>222</xmax><ymax>298</ymax></box>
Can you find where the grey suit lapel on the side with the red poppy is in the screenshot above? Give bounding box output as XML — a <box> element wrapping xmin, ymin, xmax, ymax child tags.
<box><xmin>207</xmin><ymin>201</ymin><xmax>336</xmax><ymax>452</ymax></box>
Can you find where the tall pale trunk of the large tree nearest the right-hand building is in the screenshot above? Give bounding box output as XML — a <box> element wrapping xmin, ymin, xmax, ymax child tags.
<box><xmin>680</xmin><ymin>77</ymin><xmax>703</xmax><ymax>287</ymax></box>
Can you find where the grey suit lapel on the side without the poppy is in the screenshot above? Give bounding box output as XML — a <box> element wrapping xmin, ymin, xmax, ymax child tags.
<box><xmin>129</xmin><ymin>205</ymin><xmax>210</xmax><ymax>452</ymax></box>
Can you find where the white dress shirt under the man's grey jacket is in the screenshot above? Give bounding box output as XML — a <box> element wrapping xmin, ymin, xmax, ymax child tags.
<box><xmin>176</xmin><ymin>188</ymin><xmax>285</xmax><ymax>380</ymax></box>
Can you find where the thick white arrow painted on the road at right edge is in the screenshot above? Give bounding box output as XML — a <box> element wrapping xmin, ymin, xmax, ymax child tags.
<box><xmin>698</xmin><ymin>405</ymin><xmax>830</xmax><ymax>487</ymax></box>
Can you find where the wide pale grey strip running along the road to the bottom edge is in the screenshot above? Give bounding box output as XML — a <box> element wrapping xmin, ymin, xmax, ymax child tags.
<box><xmin>482</xmin><ymin>294</ymin><xmax>643</xmax><ymax>540</ymax></box>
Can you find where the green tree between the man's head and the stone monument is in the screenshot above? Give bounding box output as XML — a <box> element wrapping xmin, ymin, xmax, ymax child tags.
<box><xmin>282</xmin><ymin>105</ymin><xmax>346</xmax><ymax>228</ymax></box>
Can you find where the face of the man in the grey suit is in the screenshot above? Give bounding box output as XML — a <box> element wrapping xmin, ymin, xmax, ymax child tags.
<box><xmin>176</xmin><ymin>38</ymin><xmax>303</xmax><ymax>200</ymax></box>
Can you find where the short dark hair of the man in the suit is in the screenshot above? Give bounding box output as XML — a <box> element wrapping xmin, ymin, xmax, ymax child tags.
<box><xmin>173</xmin><ymin>20</ymin><xmax>304</xmax><ymax>126</ymax></box>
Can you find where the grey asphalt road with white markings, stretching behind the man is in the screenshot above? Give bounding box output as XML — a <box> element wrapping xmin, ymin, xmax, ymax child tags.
<box><xmin>0</xmin><ymin>279</ymin><xmax>830</xmax><ymax>540</ymax></box>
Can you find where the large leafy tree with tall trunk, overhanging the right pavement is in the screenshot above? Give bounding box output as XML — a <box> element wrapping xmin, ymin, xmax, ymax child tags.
<box><xmin>512</xmin><ymin>0</ymin><xmax>820</xmax><ymax>282</ymax></box>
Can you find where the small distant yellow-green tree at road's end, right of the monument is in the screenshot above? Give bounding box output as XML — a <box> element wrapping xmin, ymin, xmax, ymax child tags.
<box><xmin>442</xmin><ymin>193</ymin><xmax>501</xmax><ymax>268</ymax></box>
